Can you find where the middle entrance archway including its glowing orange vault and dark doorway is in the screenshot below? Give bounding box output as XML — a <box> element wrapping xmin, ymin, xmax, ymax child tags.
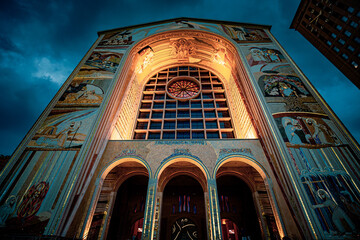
<box><xmin>157</xmin><ymin>156</ymin><xmax>208</xmax><ymax>240</ymax></box>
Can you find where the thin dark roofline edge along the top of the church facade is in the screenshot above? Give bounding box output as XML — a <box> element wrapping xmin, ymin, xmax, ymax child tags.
<box><xmin>97</xmin><ymin>17</ymin><xmax>271</xmax><ymax>36</ymax></box>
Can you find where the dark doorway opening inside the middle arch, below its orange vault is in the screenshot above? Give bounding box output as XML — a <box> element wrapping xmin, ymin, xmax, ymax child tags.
<box><xmin>160</xmin><ymin>175</ymin><xmax>206</xmax><ymax>240</ymax></box>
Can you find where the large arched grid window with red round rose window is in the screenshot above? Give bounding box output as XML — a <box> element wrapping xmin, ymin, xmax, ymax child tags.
<box><xmin>134</xmin><ymin>66</ymin><xmax>235</xmax><ymax>139</ymax></box>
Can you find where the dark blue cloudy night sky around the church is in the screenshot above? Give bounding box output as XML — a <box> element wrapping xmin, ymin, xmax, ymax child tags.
<box><xmin>0</xmin><ymin>0</ymin><xmax>360</xmax><ymax>155</ymax></box>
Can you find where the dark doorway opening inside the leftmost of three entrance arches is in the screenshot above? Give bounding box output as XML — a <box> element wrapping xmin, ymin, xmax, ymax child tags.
<box><xmin>107</xmin><ymin>175</ymin><xmax>148</xmax><ymax>240</ymax></box>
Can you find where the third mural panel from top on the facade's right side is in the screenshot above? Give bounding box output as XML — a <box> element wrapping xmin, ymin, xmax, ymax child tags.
<box><xmin>259</xmin><ymin>75</ymin><xmax>310</xmax><ymax>97</ymax></box>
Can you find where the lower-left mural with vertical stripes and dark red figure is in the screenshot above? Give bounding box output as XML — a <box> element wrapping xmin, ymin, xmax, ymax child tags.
<box><xmin>0</xmin><ymin>151</ymin><xmax>78</xmax><ymax>234</ymax></box>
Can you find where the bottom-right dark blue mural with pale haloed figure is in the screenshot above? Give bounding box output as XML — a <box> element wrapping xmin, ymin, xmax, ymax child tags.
<box><xmin>301</xmin><ymin>170</ymin><xmax>360</xmax><ymax>235</ymax></box>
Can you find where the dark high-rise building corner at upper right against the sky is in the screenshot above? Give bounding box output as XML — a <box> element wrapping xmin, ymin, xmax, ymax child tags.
<box><xmin>290</xmin><ymin>0</ymin><xmax>360</xmax><ymax>88</ymax></box>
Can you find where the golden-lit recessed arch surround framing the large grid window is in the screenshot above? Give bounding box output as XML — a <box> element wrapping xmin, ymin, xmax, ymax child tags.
<box><xmin>110</xmin><ymin>33</ymin><xmax>257</xmax><ymax>140</ymax></box>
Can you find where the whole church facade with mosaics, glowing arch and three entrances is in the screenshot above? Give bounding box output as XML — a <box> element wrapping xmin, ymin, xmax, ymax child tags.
<box><xmin>0</xmin><ymin>18</ymin><xmax>360</xmax><ymax>240</ymax></box>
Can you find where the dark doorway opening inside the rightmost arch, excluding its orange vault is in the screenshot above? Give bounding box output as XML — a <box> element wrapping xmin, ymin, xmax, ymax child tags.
<box><xmin>216</xmin><ymin>175</ymin><xmax>261</xmax><ymax>240</ymax></box>
